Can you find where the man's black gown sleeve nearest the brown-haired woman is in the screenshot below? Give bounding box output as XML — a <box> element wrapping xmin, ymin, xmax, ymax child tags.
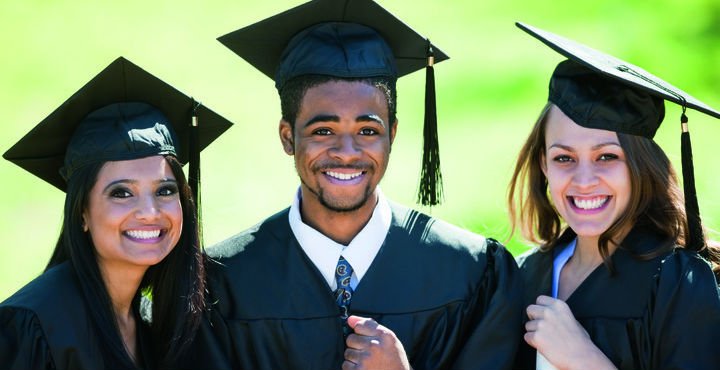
<box><xmin>452</xmin><ymin>239</ymin><xmax>523</xmax><ymax>370</ymax></box>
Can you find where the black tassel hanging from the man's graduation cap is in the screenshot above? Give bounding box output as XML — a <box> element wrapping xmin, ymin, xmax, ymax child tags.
<box><xmin>418</xmin><ymin>40</ymin><xmax>443</xmax><ymax>206</ymax></box>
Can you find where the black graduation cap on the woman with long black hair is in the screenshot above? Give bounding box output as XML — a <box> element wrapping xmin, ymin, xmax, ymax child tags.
<box><xmin>3</xmin><ymin>57</ymin><xmax>232</xmax><ymax>199</ymax></box>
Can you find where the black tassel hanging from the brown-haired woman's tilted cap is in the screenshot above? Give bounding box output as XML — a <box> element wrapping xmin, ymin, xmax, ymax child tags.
<box><xmin>680</xmin><ymin>112</ymin><xmax>705</xmax><ymax>251</ymax></box>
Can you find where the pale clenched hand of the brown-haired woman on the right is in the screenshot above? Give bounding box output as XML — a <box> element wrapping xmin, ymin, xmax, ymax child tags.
<box><xmin>524</xmin><ymin>295</ymin><xmax>616</xmax><ymax>369</ymax></box>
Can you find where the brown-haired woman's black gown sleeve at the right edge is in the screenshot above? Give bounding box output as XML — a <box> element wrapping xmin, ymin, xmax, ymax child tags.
<box><xmin>647</xmin><ymin>250</ymin><xmax>720</xmax><ymax>369</ymax></box>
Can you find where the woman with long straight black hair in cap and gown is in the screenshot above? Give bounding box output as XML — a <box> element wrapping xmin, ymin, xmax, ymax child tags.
<box><xmin>0</xmin><ymin>58</ymin><xmax>231</xmax><ymax>370</ymax></box>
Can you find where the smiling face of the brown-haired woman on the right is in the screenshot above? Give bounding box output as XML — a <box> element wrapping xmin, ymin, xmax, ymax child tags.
<box><xmin>542</xmin><ymin>106</ymin><xmax>631</xmax><ymax>237</ymax></box>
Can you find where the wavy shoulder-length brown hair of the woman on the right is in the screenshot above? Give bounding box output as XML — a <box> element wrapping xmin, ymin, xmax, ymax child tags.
<box><xmin>507</xmin><ymin>103</ymin><xmax>720</xmax><ymax>270</ymax></box>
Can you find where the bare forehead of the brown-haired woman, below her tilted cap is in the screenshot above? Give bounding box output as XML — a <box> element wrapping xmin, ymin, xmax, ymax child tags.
<box><xmin>545</xmin><ymin>106</ymin><xmax>620</xmax><ymax>147</ymax></box>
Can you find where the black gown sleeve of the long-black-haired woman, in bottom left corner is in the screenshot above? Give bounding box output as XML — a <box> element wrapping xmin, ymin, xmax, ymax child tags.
<box><xmin>0</xmin><ymin>307</ymin><xmax>55</xmax><ymax>370</ymax></box>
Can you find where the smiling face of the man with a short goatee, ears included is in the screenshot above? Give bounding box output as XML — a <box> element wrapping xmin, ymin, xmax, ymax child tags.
<box><xmin>280</xmin><ymin>81</ymin><xmax>397</xmax><ymax>212</ymax></box>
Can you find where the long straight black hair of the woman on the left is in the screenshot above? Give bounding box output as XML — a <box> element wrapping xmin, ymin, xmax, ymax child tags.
<box><xmin>46</xmin><ymin>156</ymin><xmax>206</xmax><ymax>368</ymax></box>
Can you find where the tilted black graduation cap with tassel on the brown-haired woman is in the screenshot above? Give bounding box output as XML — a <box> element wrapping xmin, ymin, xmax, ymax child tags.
<box><xmin>516</xmin><ymin>22</ymin><xmax>720</xmax><ymax>251</ymax></box>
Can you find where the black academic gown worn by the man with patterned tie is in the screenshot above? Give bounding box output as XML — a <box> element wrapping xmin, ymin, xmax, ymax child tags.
<box><xmin>186</xmin><ymin>205</ymin><xmax>522</xmax><ymax>370</ymax></box>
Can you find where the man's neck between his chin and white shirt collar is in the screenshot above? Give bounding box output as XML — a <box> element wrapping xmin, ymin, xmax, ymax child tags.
<box><xmin>300</xmin><ymin>190</ymin><xmax>378</xmax><ymax>245</ymax></box>
